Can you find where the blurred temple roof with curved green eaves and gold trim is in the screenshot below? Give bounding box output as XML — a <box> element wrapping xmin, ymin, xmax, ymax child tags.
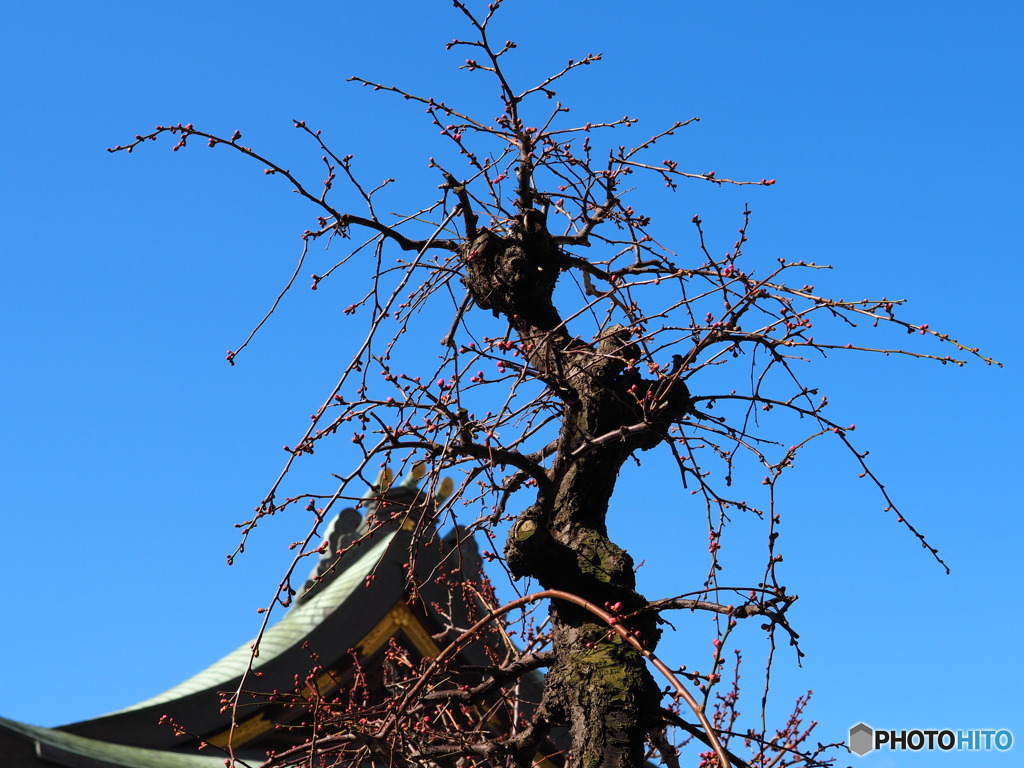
<box><xmin>0</xmin><ymin>468</ymin><xmax>562</xmax><ymax>768</ymax></box>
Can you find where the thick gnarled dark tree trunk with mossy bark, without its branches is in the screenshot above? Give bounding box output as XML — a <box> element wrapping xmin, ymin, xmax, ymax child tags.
<box><xmin>462</xmin><ymin>208</ymin><xmax>689</xmax><ymax>768</ymax></box>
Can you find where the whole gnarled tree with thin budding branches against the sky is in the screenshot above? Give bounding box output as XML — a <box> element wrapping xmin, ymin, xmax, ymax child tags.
<box><xmin>112</xmin><ymin>0</ymin><xmax>991</xmax><ymax>768</ymax></box>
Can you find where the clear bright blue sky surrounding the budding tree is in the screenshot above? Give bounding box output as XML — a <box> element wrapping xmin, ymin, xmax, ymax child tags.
<box><xmin>0</xmin><ymin>0</ymin><xmax>1024</xmax><ymax>766</ymax></box>
